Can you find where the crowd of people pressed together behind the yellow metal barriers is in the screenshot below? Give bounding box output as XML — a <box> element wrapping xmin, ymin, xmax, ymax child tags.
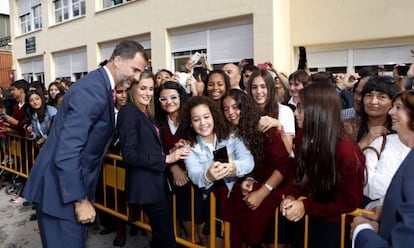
<box><xmin>0</xmin><ymin>45</ymin><xmax>414</xmax><ymax>247</ymax></box>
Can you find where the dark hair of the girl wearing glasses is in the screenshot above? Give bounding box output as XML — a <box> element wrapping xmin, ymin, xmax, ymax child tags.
<box><xmin>154</xmin><ymin>81</ymin><xmax>188</xmax><ymax>123</ymax></box>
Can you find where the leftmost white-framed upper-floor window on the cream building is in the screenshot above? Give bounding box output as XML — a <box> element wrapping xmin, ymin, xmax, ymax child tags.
<box><xmin>18</xmin><ymin>0</ymin><xmax>42</xmax><ymax>34</ymax></box>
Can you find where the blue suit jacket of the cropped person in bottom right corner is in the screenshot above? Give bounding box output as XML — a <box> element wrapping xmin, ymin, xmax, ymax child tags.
<box><xmin>355</xmin><ymin>149</ymin><xmax>414</xmax><ymax>248</ymax></box>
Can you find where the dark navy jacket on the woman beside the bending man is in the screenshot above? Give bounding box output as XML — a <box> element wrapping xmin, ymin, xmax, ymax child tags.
<box><xmin>117</xmin><ymin>103</ymin><xmax>168</xmax><ymax>204</ymax></box>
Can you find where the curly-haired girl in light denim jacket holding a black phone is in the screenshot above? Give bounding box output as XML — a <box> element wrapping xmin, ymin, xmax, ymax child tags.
<box><xmin>181</xmin><ymin>96</ymin><xmax>254</xmax><ymax>247</ymax></box>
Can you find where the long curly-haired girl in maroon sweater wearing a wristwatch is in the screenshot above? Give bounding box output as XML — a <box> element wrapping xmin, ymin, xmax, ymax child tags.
<box><xmin>222</xmin><ymin>89</ymin><xmax>294</xmax><ymax>247</ymax></box>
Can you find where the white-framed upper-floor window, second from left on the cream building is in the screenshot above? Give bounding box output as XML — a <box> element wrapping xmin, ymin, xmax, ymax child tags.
<box><xmin>53</xmin><ymin>0</ymin><xmax>86</xmax><ymax>23</ymax></box>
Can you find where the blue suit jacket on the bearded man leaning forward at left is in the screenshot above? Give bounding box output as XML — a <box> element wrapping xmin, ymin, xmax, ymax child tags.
<box><xmin>23</xmin><ymin>68</ymin><xmax>115</xmax><ymax>220</ymax></box>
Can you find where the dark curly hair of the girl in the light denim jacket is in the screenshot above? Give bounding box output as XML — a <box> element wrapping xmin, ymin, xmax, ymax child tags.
<box><xmin>180</xmin><ymin>96</ymin><xmax>230</xmax><ymax>145</ymax></box>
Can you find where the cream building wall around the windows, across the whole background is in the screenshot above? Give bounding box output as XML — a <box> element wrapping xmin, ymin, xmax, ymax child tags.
<box><xmin>10</xmin><ymin>0</ymin><xmax>414</xmax><ymax>83</ymax></box>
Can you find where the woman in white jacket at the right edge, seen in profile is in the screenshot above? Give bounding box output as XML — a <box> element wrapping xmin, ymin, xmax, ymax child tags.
<box><xmin>364</xmin><ymin>90</ymin><xmax>414</xmax><ymax>210</ymax></box>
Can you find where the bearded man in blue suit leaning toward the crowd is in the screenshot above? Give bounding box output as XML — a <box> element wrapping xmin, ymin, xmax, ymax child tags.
<box><xmin>23</xmin><ymin>41</ymin><xmax>148</xmax><ymax>248</ymax></box>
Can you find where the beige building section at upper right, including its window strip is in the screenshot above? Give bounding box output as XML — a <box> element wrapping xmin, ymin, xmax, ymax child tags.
<box><xmin>291</xmin><ymin>0</ymin><xmax>414</xmax><ymax>74</ymax></box>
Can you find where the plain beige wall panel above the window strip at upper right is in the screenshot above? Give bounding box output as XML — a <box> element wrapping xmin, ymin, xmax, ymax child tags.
<box><xmin>291</xmin><ymin>0</ymin><xmax>414</xmax><ymax>46</ymax></box>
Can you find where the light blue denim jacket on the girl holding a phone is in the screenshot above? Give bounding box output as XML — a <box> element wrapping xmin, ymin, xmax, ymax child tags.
<box><xmin>185</xmin><ymin>135</ymin><xmax>254</xmax><ymax>197</ymax></box>
